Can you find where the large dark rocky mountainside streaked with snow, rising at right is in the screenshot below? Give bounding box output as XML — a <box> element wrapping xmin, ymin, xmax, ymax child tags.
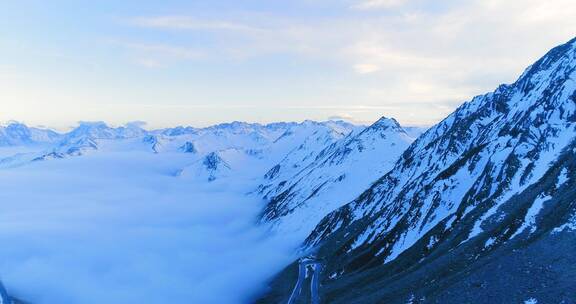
<box><xmin>260</xmin><ymin>39</ymin><xmax>576</xmax><ymax>303</ymax></box>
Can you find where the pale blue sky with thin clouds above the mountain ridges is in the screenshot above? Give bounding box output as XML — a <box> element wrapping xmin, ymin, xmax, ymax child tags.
<box><xmin>0</xmin><ymin>0</ymin><xmax>576</xmax><ymax>128</ymax></box>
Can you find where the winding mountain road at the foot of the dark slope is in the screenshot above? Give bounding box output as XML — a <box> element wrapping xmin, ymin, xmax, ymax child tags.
<box><xmin>288</xmin><ymin>257</ymin><xmax>322</xmax><ymax>304</ymax></box>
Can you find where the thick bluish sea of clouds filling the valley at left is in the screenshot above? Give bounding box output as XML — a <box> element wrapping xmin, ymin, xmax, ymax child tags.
<box><xmin>0</xmin><ymin>152</ymin><xmax>295</xmax><ymax>304</ymax></box>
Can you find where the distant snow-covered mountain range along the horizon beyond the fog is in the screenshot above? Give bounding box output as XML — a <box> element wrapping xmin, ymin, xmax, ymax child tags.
<box><xmin>0</xmin><ymin>121</ymin><xmax>361</xmax><ymax>180</ymax></box>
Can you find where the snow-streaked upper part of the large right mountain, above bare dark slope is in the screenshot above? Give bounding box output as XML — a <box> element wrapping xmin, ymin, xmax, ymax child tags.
<box><xmin>313</xmin><ymin>36</ymin><xmax>576</xmax><ymax>249</ymax></box>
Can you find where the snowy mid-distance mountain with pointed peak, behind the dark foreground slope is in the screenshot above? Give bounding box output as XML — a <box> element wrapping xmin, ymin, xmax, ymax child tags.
<box><xmin>259</xmin><ymin>118</ymin><xmax>413</xmax><ymax>237</ymax></box>
